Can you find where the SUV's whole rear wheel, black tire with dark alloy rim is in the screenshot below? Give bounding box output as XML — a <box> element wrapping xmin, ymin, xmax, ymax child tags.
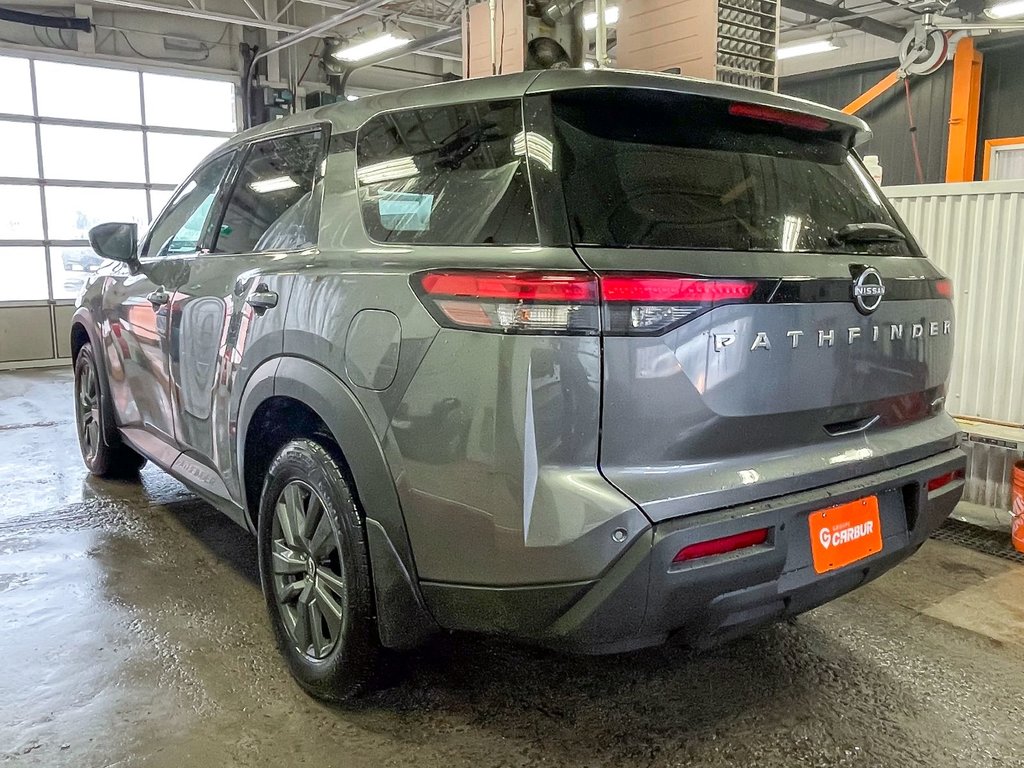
<box><xmin>258</xmin><ymin>438</ymin><xmax>381</xmax><ymax>701</ymax></box>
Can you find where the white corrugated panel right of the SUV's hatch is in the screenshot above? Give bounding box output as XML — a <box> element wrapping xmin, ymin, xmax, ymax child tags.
<box><xmin>885</xmin><ymin>180</ymin><xmax>1024</xmax><ymax>425</ymax></box>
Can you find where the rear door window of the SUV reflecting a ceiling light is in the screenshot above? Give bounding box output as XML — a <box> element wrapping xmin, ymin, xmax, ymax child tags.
<box><xmin>213</xmin><ymin>129</ymin><xmax>324</xmax><ymax>253</ymax></box>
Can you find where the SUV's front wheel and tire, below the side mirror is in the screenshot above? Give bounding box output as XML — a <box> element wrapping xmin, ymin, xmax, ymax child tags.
<box><xmin>75</xmin><ymin>344</ymin><xmax>145</xmax><ymax>478</ymax></box>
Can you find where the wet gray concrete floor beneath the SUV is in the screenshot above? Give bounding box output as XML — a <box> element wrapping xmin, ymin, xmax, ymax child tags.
<box><xmin>0</xmin><ymin>371</ymin><xmax>1024</xmax><ymax>768</ymax></box>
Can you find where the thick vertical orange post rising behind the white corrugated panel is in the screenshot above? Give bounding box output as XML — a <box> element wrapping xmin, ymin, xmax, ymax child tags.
<box><xmin>946</xmin><ymin>37</ymin><xmax>982</xmax><ymax>181</ymax></box>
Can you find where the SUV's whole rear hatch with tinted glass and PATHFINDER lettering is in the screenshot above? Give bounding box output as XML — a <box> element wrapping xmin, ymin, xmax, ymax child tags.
<box><xmin>551</xmin><ymin>88</ymin><xmax>955</xmax><ymax>520</ymax></box>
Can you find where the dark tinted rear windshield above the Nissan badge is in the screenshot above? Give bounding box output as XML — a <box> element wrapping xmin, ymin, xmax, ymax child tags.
<box><xmin>552</xmin><ymin>88</ymin><xmax>919</xmax><ymax>255</ymax></box>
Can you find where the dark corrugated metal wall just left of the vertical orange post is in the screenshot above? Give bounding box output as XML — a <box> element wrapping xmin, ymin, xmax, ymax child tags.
<box><xmin>778</xmin><ymin>60</ymin><xmax>954</xmax><ymax>184</ymax></box>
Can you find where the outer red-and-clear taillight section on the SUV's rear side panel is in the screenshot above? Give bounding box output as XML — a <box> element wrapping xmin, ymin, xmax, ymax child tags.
<box><xmin>413</xmin><ymin>270</ymin><xmax>599</xmax><ymax>335</ymax></box>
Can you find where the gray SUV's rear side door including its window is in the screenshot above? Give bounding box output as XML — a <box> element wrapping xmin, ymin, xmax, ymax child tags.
<box><xmin>170</xmin><ymin>126</ymin><xmax>327</xmax><ymax>512</ymax></box>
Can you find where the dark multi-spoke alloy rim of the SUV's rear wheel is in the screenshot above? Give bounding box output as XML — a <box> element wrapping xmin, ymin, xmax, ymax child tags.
<box><xmin>270</xmin><ymin>480</ymin><xmax>346</xmax><ymax>660</ymax></box>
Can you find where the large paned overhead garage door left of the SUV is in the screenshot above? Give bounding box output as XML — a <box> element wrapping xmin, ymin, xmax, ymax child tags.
<box><xmin>0</xmin><ymin>55</ymin><xmax>237</xmax><ymax>368</ymax></box>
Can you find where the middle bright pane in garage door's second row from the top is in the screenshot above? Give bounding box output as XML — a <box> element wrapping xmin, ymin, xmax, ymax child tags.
<box><xmin>42</xmin><ymin>125</ymin><xmax>145</xmax><ymax>181</ymax></box>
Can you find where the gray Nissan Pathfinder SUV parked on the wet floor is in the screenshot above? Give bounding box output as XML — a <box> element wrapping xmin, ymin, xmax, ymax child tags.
<box><xmin>72</xmin><ymin>71</ymin><xmax>965</xmax><ymax>699</ymax></box>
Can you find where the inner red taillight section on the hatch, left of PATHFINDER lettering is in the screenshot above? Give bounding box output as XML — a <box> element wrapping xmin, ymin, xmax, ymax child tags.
<box><xmin>601</xmin><ymin>274</ymin><xmax>757</xmax><ymax>336</ymax></box>
